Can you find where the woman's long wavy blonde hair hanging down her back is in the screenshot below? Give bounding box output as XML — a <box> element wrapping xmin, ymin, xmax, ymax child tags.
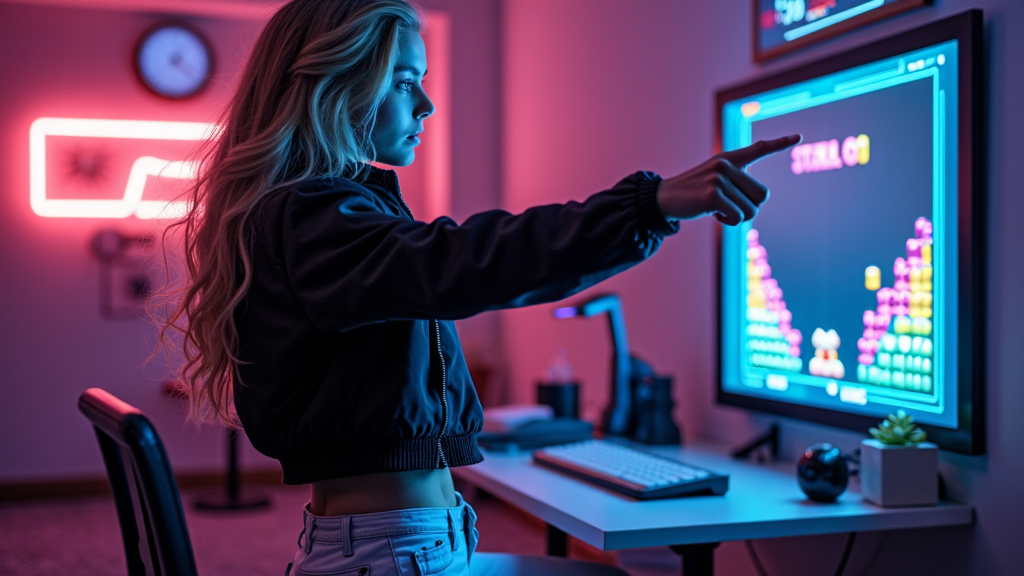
<box><xmin>157</xmin><ymin>0</ymin><xmax>420</xmax><ymax>425</ymax></box>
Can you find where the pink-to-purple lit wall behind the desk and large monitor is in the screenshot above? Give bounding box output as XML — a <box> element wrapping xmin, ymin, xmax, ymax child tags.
<box><xmin>502</xmin><ymin>0</ymin><xmax>1024</xmax><ymax>575</ymax></box>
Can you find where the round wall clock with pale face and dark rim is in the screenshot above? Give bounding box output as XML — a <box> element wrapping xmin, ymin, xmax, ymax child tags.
<box><xmin>136</xmin><ymin>25</ymin><xmax>212</xmax><ymax>98</ymax></box>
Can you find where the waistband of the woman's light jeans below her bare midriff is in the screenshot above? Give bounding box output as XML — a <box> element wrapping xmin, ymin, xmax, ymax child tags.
<box><xmin>299</xmin><ymin>492</ymin><xmax>467</xmax><ymax>556</ymax></box>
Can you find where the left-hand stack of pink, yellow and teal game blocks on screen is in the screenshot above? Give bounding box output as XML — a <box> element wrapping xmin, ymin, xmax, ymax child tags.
<box><xmin>746</xmin><ymin>230</ymin><xmax>798</xmax><ymax>372</ymax></box>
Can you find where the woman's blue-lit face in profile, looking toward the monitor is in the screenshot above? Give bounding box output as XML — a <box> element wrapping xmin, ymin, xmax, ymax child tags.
<box><xmin>370</xmin><ymin>31</ymin><xmax>434</xmax><ymax>166</ymax></box>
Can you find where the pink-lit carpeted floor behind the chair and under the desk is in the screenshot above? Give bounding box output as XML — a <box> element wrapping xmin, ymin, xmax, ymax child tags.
<box><xmin>0</xmin><ymin>487</ymin><xmax>679</xmax><ymax>576</ymax></box>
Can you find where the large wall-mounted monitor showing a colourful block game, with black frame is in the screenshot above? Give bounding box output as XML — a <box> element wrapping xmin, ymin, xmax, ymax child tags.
<box><xmin>718</xmin><ymin>10</ymin><xmax>984</xmax><ymax>454</ymax></box>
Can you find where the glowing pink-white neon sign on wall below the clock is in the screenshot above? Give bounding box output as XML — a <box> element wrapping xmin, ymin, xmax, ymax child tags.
<box><xmin>29</xmin><ymin>118</ymin><xmax>218</xmax><ymax>219</ymax></box>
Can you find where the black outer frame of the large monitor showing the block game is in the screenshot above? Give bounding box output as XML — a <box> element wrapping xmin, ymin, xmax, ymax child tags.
<box><xmin>715</xmin><ymin>10</ymin><xmax>985</xmax><ymax>455</ymax></box>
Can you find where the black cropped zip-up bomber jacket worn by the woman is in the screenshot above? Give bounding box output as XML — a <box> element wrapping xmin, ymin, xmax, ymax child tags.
<box><xmin>234</xmin><ymin>163</ymin><xmax>678</xmax><ymax>484</ymax></box>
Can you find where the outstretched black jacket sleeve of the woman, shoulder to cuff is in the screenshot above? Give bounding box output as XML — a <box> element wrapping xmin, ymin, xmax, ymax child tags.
<box><xmin>278</xmin><ymin>172</ymin><xmax>678</xmax><ymax>331</ymax></box>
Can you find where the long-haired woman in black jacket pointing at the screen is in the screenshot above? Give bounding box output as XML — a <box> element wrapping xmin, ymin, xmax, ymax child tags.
<box><xmin>164</xmin><ymin>0</ymin><xmax>799</xmax><ymax>576</ymax></box>
